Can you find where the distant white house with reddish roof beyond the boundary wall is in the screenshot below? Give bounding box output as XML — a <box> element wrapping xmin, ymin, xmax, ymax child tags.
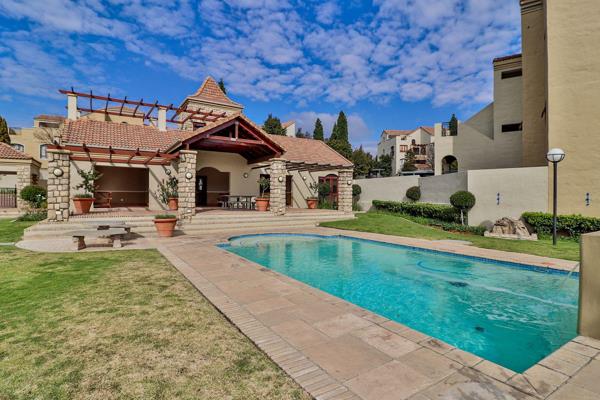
<box><xmin>377</xmin><ymin>126</ymin><xmax>434</xmax><ymax>176</ymax></box>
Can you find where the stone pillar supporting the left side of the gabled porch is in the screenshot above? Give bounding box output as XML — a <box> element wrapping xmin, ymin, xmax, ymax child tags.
<box><xmin>177</xmin><ymin>150</ymin><xmax>198</xmax><ymax>221</ymax></box>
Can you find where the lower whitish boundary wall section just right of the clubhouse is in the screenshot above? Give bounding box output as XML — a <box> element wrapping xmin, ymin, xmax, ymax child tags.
<box><xmin>354</xmin><ymin>176</ymin><xmax>419</xmax><ymax>211</ymax></box>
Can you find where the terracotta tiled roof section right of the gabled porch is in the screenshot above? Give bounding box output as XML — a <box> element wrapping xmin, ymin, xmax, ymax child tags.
<box><xmin>269</xmin><ymin>135</ymin><xmax>352</xmax><ymax>167</ymax></box>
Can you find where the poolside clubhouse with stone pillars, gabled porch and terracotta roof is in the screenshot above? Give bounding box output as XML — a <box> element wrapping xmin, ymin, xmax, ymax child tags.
<box><xmin>38</xmin><ymin>77</ymin><xmax>353</xmax><ymax>221</ymax></box>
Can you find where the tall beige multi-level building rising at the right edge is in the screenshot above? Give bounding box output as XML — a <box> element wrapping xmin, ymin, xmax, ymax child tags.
<box><xmin>435</xmin><ymin>0</ymin><xmax>600</xmax><ymax>216</ymax></box>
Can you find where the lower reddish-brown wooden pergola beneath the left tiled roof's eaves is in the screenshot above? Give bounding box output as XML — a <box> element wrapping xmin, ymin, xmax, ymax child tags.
<box><xmin>48</xmin><ymin>143</ymin><xmax>179</xmax><ymax>165</ymax></box>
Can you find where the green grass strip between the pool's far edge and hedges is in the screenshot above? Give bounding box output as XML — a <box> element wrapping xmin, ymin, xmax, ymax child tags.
<box><xmin>321</xmin><ymin>212</ymin><xmax>579</xmax><ymax>261</ymax></box>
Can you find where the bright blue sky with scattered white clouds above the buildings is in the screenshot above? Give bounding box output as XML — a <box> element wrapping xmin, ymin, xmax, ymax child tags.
<box><xmin>0</xmin><ymin>0</ymin><xmax>520</xmax><ymax>150</ymax></box>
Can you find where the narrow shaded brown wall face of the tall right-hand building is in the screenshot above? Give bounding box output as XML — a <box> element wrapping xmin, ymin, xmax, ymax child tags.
<box><xmin>521</xmin><ymin>0</ymin><xmax>548</xmax><ymax>167</ymax></box>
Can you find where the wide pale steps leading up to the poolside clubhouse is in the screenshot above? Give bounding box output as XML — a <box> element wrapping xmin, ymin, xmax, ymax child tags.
<box><xmin>23</xmin><ymin>210</ymin><xmax>353</xmax><ymax>240</ymax></box>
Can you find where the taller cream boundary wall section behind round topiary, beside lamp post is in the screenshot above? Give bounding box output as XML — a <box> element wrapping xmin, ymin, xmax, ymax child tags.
<box><xmin>467</xmin><ymin>167</ymin><xmax>548</xmax><ymax>228</ymax></box>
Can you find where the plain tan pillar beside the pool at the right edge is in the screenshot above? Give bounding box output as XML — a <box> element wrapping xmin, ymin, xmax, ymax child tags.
<box><xmin>577</xmin><ymin>232</ymin><xmax>600</xmax><ymax>339</ymax></box>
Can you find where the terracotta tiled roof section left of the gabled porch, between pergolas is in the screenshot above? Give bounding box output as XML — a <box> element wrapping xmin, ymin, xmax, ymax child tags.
<box><xmin>62</xmin><ymin>118</ymin><xmax>191</xmax><ymax>151</ymax></box>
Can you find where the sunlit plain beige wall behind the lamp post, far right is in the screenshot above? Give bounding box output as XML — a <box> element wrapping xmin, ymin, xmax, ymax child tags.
<box><xmin>546</xmin><ymin>0</ymin><xmax>600</xmax><ymax>217</ymax></box>
